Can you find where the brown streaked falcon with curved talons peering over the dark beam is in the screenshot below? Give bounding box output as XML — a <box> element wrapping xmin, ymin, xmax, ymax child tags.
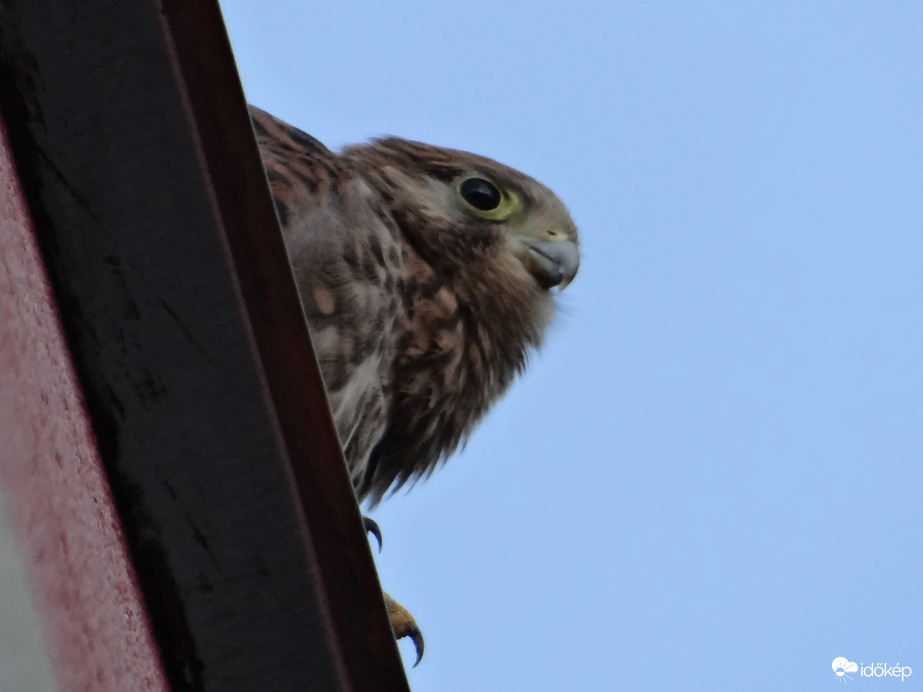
<box><xmin>250</xmin><ymin>106</ymin><xmax>580</xmax><ymax>665</ymax></box>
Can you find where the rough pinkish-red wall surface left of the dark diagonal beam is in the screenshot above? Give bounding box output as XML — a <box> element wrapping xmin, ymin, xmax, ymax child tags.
<box><xmin>0</xmin><ymin>116</ymin><xmax>169</xmax><ymax>692</ymax></box>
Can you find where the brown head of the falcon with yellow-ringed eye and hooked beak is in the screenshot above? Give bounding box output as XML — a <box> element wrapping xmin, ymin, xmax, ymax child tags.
<box><xmin>345</xmin><ymin>138</ymin><xmax>580</xmax><ymax>292</ymax></box>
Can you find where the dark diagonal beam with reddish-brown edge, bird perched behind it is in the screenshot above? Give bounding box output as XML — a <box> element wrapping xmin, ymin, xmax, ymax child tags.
<box><xmin>0</xmin><ymin>0</ymin><xmax>408</xmax><ymax>692</ymax></box>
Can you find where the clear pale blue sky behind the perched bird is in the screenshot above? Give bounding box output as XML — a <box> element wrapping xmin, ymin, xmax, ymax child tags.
<box><xmin>222</xmin><ymin>0</ymin><xmax>923</xmax><ymax>692</ymax></box>
